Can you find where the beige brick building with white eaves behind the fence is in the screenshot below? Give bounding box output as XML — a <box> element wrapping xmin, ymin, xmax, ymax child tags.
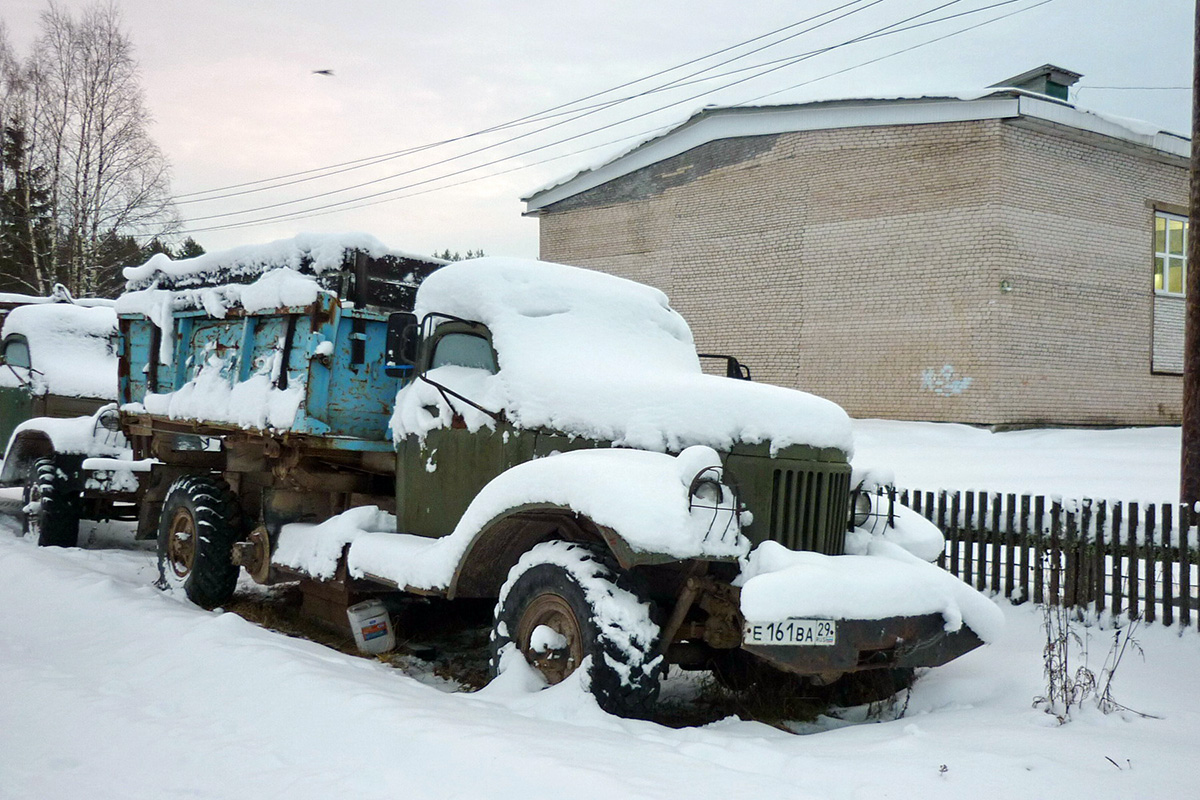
<box><xmin>526</xmin><ymin>66</ymin><xmax>1189</xmax><ymax>425</ymax></box>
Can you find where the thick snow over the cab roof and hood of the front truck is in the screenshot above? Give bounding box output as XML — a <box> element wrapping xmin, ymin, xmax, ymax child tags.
<box><xmin>392</xmin><ymin>258</ymin><xmax>852</xmax><ymax>453</ymax></box>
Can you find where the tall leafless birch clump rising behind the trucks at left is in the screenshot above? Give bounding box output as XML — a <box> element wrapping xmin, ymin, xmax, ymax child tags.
<box><xmin>5</xmin><ymin>2</ymin><xmax>179</xmax><ymax>295</ymax></box>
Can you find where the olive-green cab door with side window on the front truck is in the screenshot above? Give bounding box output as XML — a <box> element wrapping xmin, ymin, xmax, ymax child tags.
<box><xmin>396</xmin><ymin>321</ymin><xmax>509</xmax><ymax>536</ymax></box>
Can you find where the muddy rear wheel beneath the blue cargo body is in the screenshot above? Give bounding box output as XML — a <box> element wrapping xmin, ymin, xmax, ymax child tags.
<box><xmin>158</xmin><ymin>475</ymin><xmax>241</xmax><ymax>608</ymax></box>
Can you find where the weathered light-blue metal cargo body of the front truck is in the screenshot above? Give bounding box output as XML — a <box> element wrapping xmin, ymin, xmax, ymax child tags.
<box><xmin>120</xmin><ymin>294</ymin><xmax>401</xmax><ymax>450</ymax></box>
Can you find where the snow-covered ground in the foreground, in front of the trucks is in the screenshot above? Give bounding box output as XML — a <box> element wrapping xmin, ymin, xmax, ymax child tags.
<box><xmin>0</xmin><ymin>517</ymin><xmax>1200</xmax><ymax>800</ymax></box>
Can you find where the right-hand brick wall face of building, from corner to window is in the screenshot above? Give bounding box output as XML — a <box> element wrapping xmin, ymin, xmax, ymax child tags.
<box><xmin>990</xmin><ymin>124</ymin><xmax>1188</xmax><ymax>425</ymax></box>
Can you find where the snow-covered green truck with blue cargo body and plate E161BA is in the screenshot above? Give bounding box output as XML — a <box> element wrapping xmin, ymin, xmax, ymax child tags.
<box><xmin>11</xmin><ymin>240</ymin><xmax>1000</xmax><ymax>715</ymax></box>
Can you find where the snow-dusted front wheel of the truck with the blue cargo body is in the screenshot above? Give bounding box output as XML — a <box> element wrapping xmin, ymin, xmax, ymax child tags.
<box><xmin>492</xmin><ymin>541</ymin><xmax>664</xmax><ymax>718</ymax></box>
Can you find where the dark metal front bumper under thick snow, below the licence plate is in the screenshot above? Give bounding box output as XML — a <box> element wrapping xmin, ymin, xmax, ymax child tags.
<box><xmin>742</xmin><ymin>614</ymin><xmax>983</xmax><ymax>675</ymax></box>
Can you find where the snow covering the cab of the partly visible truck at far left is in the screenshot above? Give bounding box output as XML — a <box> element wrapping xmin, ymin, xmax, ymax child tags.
<box><xmin>0</xmin><ymin>302</ymin><xmax>116</xmax><ymax>399</ymax></box>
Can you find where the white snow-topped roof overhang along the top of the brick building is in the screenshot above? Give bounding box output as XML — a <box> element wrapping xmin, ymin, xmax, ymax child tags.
<box><xmin>522</xmin><ymin>88</ymin><xmax>1190</xmax><ymax>215</ymax></box>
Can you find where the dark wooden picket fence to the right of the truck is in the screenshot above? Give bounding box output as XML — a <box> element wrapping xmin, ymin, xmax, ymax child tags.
<box><xmin>896</xmin><ymin>489</ymin><xmax>1200</xmax><ymax>626</ymax></box>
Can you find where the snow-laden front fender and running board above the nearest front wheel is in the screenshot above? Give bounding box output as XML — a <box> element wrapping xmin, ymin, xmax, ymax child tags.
<box><xmin>338</xmin><ymin>447</ymin><xmax>750</xmax><ymax>597</ymax></box>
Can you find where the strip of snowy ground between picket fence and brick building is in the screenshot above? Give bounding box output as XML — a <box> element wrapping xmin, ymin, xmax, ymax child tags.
<box><xmin>853</xmin><ymin>420</ymin><xmax>1180</xmax><ymax>503</ymax></box>
